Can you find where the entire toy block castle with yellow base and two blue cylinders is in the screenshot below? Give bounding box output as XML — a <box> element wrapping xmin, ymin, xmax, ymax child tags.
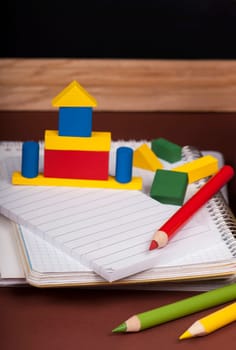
<box><xmin>12</xmin><ymin>81</ymin><xmax>142</xmax><ymax>189</ymax></box>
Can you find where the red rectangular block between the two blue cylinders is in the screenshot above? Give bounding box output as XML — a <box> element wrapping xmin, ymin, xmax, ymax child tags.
<box><xmin>44</xmin><ymin>150</ymin><xmax>109</xmax><ymax>180</ymax></box>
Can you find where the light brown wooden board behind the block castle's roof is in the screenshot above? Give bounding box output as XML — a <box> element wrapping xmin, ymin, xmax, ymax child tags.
<box><xmin>0</xmin><ymin>59</ymin><xmax>236</xmax><ymax>112</ymax></box>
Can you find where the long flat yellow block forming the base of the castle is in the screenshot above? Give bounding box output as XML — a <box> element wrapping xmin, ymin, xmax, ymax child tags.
<box><xmin>12</xmin><ymin>171</ymin><xmax>142</xmax><ymax>190</ymax></box>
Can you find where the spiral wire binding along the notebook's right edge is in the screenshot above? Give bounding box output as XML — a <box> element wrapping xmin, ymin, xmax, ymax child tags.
<box><xmin>182</xmin><ymin>146</ymin><xmax>236</xmax><ymax>257</ymax></box>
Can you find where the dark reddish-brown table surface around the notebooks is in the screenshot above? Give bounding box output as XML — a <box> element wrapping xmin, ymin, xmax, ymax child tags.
<box><xmin>0</xmin><ymin>111</ymin><xmax>236</xmax><ymax>350</ymax></box>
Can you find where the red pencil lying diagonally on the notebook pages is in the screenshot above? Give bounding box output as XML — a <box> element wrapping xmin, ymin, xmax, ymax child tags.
<box><xmin>149</xmin><ymin>165</ymin><xmax>234</xmax><ymax>250</ymax></box>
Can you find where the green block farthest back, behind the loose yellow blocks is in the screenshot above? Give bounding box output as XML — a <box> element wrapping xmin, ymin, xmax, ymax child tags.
<box><xmin>151</xmin><ymin>137</ymin><xmax>182</xmax><ymax>163</ymax></box>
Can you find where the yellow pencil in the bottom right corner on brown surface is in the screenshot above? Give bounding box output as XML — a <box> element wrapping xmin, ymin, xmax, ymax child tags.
<box><xmin>179</xmin><ymin>302</ymin><xmax>236</xmax><ymax>339</ymax></box>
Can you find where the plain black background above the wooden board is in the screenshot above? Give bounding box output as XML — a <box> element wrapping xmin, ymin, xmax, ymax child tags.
<box><xmin>0</xmin><ymin>0</ymin><xmax>236</xmax><ymax>59</ymax></box>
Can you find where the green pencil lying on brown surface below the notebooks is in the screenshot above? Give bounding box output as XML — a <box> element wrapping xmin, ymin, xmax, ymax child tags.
<box><xmin>112</xmin><ymin>283</ymin><xmax>236</xmax><ymax>333</ymax></box>
